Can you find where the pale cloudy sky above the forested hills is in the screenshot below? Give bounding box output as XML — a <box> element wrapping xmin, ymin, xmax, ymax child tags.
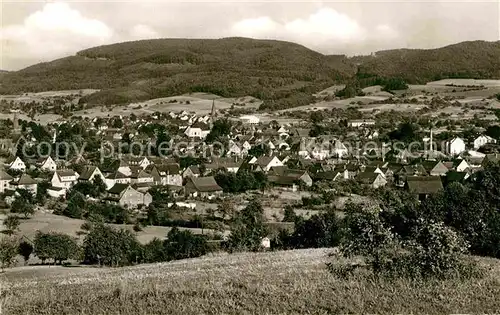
<box><xmin>0</xmin><ymin>0</ymin><xmax>500</xmax><ymax>70</ymax></box>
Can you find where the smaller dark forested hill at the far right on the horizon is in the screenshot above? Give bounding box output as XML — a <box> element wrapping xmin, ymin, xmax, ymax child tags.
<box><xmin>353</xmin><ymin>41</ymin><xmax>500</xmax><ymax>84</ymax></box>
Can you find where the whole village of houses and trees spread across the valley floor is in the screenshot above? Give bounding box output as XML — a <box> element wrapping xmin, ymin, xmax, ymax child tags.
<box><xmin>0</xmin><ymin>88</ymin><xmax>500</xmax><ymax>247</ymax></box>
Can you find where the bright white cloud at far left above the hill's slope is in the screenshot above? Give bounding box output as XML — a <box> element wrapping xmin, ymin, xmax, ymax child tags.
<box><xmin>0</xmin><ymin>2</ymin><xmax>114</xmax><ymax>59</ymax></box>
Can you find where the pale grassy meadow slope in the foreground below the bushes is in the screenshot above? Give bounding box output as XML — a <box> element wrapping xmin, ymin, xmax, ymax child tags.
<box><xmin>1</xmin><ymin>250</ymin><xmax>500</xmax><ymax>315</ymax></box>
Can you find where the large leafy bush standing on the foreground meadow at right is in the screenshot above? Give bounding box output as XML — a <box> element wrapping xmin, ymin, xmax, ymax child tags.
<box><xmin>328</xmin><ymin>205</ymin><xmax>477</xmax><ymax>279</ymax></box>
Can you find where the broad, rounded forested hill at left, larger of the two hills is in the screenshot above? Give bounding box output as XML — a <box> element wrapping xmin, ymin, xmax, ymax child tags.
<box><xmin>0</xmin><ymin>38</ymin><xmax>355</xmax><ymax>109</ymax></box>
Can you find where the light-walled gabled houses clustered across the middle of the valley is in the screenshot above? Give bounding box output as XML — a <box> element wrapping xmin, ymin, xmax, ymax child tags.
<box><xmin>0</xmin><ymin>108</ymin><xmax>498</xmax><ymax>208</ymax></box>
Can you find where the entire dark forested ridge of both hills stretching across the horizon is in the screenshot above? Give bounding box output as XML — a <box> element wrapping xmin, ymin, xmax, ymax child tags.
<box><xmin>0</xmin><ymin>38</ymin><xmax>500</xmax><ymax>109</ymax></box>
